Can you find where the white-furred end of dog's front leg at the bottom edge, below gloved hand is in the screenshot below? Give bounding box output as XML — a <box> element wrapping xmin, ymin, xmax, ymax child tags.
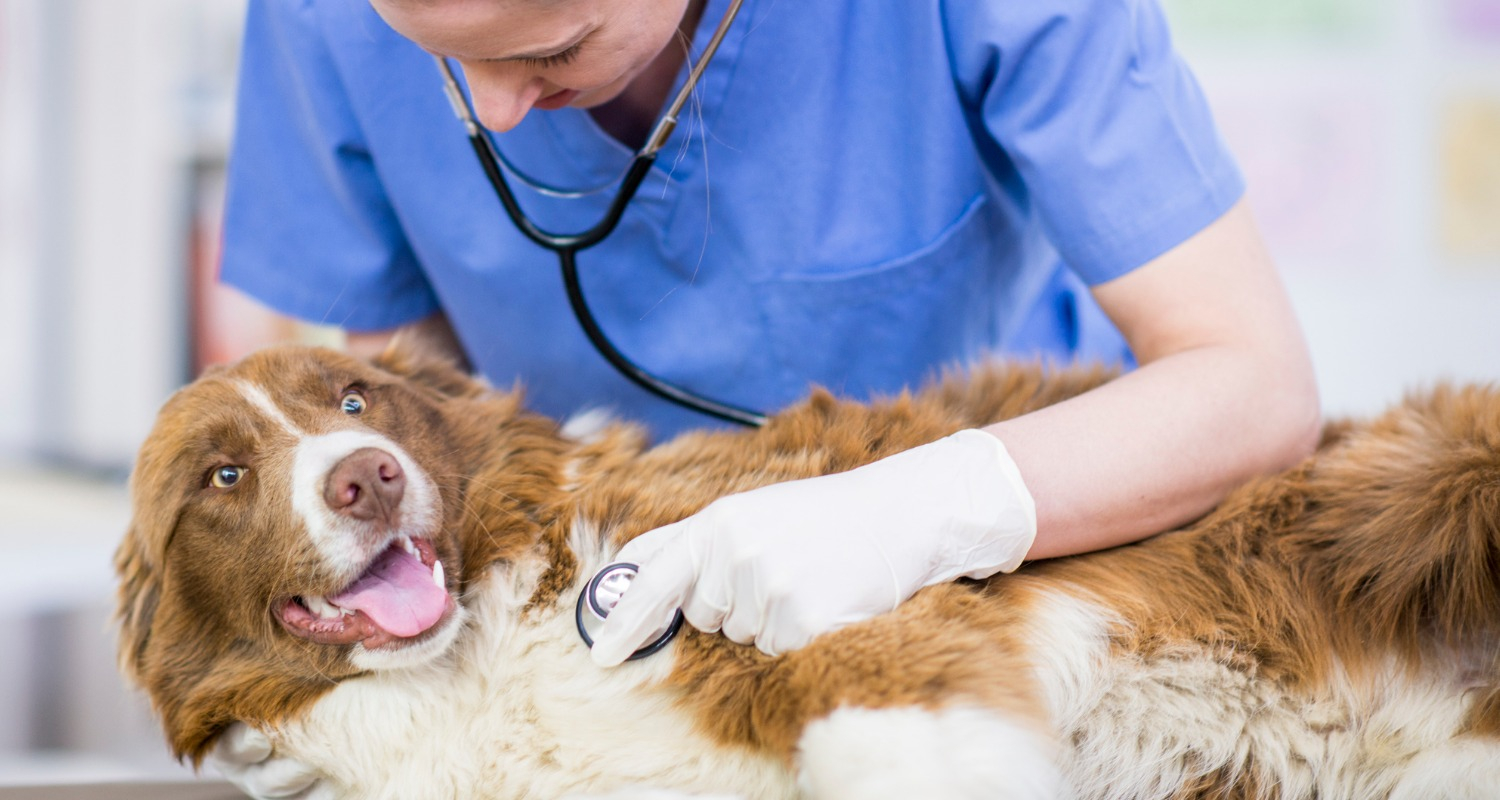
<box><xmin>798</xmin><ymin>707</ymin><xmax>1062</xmax><ymax>800</ymax></box>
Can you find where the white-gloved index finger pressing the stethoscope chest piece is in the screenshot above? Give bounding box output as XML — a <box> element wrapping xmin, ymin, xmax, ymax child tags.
<box><xmin>590</xmin><ymin>525</ymin><xmax>696</xmax><ymax>666</ymax></box>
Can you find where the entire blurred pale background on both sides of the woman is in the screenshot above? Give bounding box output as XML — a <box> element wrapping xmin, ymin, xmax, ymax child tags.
<box><xmin>0</xmin><ymin>0</ymin><xmax>1500</xmax><ymax>783</ymax></box>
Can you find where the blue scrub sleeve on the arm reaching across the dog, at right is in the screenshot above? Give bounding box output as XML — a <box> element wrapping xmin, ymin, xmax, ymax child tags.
<box><xmin>947</xmin><ymin>0</ymin><xmax>1244</xmax><ymax>285</ymax></box>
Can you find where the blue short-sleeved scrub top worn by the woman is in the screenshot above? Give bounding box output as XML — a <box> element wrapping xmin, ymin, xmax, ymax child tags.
<box><xmin>222</xmin><ymin>0</ymin><xmax>1244</xmax><ymax>435</ymax></box>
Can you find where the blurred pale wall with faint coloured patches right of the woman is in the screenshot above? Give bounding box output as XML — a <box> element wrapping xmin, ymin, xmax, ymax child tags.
<box><xmin>1167</xmin><ymin>0</ymin><xmax>1500</xmax><ymax>414</ymax></box>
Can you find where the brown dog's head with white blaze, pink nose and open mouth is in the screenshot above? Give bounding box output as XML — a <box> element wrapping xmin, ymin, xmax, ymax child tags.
<box><xmin>116</xmin><ymin>347</ymin><xmax>552</xmax><ymax>761</ymax></box>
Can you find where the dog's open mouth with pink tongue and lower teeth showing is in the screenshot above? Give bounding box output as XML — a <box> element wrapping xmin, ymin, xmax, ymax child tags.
<box><xmin>278</xmin><ymin>536</ymin><xmax>453</xmax><ymax>648</ymax></box>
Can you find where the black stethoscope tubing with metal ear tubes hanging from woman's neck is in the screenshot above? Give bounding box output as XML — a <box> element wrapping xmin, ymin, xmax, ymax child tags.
<box><xmin>437</xmin><ymin>0</ymin><xmax>765</xmax><ymax>426</ymax></box>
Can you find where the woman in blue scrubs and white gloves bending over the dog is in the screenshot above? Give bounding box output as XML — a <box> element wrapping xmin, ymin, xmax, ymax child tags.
<box><xmin>222</xmin><ymin>0</ymin><xmax>1319</xmax><ymax>788</ymax></box>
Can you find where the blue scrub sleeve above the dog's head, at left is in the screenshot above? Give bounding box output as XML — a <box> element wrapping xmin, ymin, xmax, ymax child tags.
<box><xmin>224</xmin><ymin>2</ymin><xmax>438</xmax><ymax>330</ymax></box>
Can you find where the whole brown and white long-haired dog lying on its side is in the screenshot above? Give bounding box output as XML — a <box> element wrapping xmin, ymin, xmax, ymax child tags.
<box><xmin>119</xmin><ymin>348</ymin><xmax>1500</xmax><ymax>800</ymax></box>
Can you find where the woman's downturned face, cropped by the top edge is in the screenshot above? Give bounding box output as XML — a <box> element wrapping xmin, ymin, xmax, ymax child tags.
<box><xmin>371</xmin><ymin>0</ymin><xmax>690</xmax><ymax>132</ymax></box>
